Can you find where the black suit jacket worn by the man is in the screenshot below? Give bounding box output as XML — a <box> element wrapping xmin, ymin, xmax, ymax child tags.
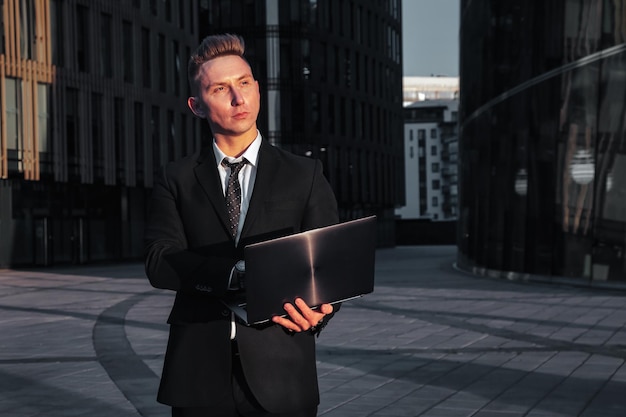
<box><xmin>145</xmin><ymin>140</ymin><xmax>338</xmax><ymax>413</ymax></box>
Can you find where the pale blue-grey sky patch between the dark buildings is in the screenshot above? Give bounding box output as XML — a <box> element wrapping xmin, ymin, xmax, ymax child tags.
<box><xmin>402</xmin><ymin>0</ymin><xmax>460</xmax><ymax>77</ymax></box>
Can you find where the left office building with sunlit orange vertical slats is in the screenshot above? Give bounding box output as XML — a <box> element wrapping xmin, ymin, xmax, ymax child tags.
<box><xmin>0</xmin><ymin>0</ymin><xmax>200</xmax><ymax>267</ymax></box>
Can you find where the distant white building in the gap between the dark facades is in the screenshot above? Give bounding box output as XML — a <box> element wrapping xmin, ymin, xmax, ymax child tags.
<box><xmin>395</xmin><ymin>96</ymin><xmax>459</xmax><ymax>245</ymax></box>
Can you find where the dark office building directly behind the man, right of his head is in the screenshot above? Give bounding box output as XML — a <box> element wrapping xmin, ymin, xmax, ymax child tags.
<box><xmin>199</xmin><ymin>0</ymin><xmax>404</xmax><ymax>245</ymax></box>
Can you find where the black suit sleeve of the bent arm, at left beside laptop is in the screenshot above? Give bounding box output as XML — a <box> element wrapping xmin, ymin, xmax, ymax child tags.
<box><xmin>144</xmin><ymin>164</ymin><xmax>237</xmax><ymax>296</ymax></box>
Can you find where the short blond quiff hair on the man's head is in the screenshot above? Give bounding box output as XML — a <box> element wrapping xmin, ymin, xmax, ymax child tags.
<box><xmin>187</xmin><ymin>33</ymin><xmax>247</xmax><ymax>94</ymax></box>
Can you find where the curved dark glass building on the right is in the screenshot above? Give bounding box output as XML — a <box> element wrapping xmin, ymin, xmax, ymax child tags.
<box><xmin>458</xmin><ymin>0</ymin><xmax>626</xmax><ymax>284</ymax></box>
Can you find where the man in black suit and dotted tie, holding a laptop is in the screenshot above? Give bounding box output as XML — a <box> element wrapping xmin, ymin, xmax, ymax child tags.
<box><xmin>145</xmin><ymin>35</ymin><xmax>338</xmax><ymax>417</ymax></box>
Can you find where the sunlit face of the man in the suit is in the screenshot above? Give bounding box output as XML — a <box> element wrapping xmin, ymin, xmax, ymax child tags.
<box><xmin>188</xmin><ymin>55</ymin><xmax>261</xmax><ymax>137</ymax></box>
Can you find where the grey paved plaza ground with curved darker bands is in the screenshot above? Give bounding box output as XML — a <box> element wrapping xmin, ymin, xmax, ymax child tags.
<box><xmin>0</xmin><ymin>247</ymin><xmax>626</xmax><ymax>417</ymax></box>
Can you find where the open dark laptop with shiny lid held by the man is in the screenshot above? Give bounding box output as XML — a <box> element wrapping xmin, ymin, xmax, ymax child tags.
<box><xmin>226</xmin><ymin>216</ymin><xmax>376</xmax><ymax>325</ymax></box>
